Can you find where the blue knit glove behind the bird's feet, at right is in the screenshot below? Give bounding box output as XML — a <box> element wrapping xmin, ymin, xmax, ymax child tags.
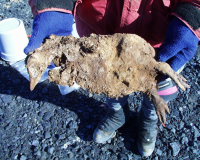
<box><xmin>157</xmin><ymin>17</ymin><xmax>199</xmax><ymax>72</ymax></box>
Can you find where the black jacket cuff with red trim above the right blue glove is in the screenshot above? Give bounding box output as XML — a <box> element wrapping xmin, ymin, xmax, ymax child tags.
<box><xmin>172</xmin><ymin>0</ymin><xmax>200</xmax><ymax>39</ymax></box>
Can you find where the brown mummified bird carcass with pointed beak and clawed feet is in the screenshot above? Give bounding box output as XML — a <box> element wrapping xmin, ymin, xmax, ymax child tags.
<box><xmin>27</xmin><ymin>34</ymin><xmax>189</xmax><ymax>122</ymax></box>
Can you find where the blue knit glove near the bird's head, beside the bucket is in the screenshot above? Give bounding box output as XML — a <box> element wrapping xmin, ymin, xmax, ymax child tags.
<box><xmin>24</xmin><ymin>11</ymin><xmax>73</xmax><ymax>54</ymax></box>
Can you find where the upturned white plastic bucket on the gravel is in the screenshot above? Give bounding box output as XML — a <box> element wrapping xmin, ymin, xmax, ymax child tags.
<box><xmin>0</xmin><ymin>18</ymin><xmax>28</xmax><ymax>62</ymax></box>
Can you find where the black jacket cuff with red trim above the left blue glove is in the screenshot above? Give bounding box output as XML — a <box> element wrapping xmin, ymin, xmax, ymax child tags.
<box><xmin>29</xmin><ymin>0</ymin><xmax>80</xmax><ymax>17</ymax></box>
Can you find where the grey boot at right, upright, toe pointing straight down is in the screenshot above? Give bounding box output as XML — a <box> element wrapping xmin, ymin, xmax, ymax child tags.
<box><xmin>137</xmin><ymin>109</ymin><xmax>158</xmax><ymax>157</ymax></box>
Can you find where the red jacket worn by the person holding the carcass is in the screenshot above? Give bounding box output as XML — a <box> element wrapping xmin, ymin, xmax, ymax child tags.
<box><xmin>29</xmin><ymin>0</ymin><xmax>200</xmax><ymax>47</ymax></box>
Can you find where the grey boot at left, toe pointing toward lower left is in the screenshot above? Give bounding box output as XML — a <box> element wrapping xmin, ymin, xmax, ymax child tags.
<box><xmin>93</xmin><ymin>103</ymin><xmax>130</xmax><ymax>143</ymax></box>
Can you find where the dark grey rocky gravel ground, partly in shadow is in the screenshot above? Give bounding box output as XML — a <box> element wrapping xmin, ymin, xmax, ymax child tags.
<box><xmin>0</xmin><ymin>0</ymin><xmax>200</xmax><ymax>160</ymax></box>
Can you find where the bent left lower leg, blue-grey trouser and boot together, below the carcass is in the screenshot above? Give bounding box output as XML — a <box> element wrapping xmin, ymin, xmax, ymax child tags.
<box><xmin>93</xmin><ymin>96</ymin><xmax>130</xmax><ymax>143</ymax></box>
